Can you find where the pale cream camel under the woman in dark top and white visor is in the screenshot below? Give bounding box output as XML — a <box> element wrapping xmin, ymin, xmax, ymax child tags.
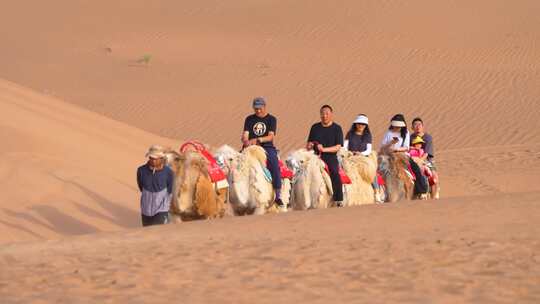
<box><xmin>338</xmin><ymin>149</ymin><xmax>377</xmax><ymax>206</ymax></box>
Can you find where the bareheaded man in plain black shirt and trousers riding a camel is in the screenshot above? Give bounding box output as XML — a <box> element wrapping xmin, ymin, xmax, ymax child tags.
<box><xmin>306</xmin><ymin>105</ymin><xmax>343</xmax><ymax>207</ymax></box>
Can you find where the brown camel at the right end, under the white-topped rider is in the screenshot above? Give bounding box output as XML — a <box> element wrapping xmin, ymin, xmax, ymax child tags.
<box><xmin>378</xmin><ymin>151</ymin><xmax>414</xmax><ymax>202</ymax></box>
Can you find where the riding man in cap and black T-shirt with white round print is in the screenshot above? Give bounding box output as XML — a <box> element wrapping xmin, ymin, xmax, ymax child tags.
<box><xmin>242</xmin><ymin>97</ymin><xmax>283</xmax><ymax>207</ymax></box>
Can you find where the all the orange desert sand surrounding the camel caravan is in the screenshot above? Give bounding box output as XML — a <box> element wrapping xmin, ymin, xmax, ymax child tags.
<box><xmin>0</xmin><ymin>0</ymin><xmax>540</xmax><ymax>303</ymax></box>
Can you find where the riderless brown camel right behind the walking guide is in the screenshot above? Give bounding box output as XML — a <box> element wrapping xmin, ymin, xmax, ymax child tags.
<box><xmin>165</xmin><ymin>149</ymin><xmax>228</xmax><ymax>222</ymax></box>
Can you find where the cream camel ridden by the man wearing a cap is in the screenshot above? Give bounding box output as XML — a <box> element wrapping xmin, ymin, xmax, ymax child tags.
<box><xmin>215</xmin><ymin>145</ymin><xmax>291</xmax><ymax>215</ymax></box>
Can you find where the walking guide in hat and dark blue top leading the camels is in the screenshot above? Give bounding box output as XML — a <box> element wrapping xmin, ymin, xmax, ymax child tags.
<box><xmin>137</xmin><ymin>145</ymin><xmax>174</xmax><ymax>226</ymax></box>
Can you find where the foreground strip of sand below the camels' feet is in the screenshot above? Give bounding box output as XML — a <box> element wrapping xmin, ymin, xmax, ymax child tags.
<box><xmin>0</xmin><ymin>192</ymin><xmax>540</xmax><ymax>303</ymax></box>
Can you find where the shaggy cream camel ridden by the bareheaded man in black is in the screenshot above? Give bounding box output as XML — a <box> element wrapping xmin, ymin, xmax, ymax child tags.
<box><xmin>287</xmin><ymin>149</ymin><xmax>333</xmax><ymax>210</ymax></box>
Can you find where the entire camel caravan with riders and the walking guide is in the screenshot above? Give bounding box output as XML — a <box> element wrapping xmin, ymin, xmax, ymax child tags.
<box><xmin>137</xmin><ymin>99</ymin><xmax>439</xmax><ymax>226</ymax></box>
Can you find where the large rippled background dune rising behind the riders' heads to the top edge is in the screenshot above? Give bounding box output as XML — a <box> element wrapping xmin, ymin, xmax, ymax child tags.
<box><xmin>0</xmin><ymin>0</ymin><xmax>540</xmax><ymax>151</ymax></box>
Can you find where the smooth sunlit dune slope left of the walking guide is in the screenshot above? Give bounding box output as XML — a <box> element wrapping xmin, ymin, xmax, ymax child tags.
<box><xmin>0</xmin><ymin>81</ymin><xmax>177</xmax><ymax>243</ymax></box>
